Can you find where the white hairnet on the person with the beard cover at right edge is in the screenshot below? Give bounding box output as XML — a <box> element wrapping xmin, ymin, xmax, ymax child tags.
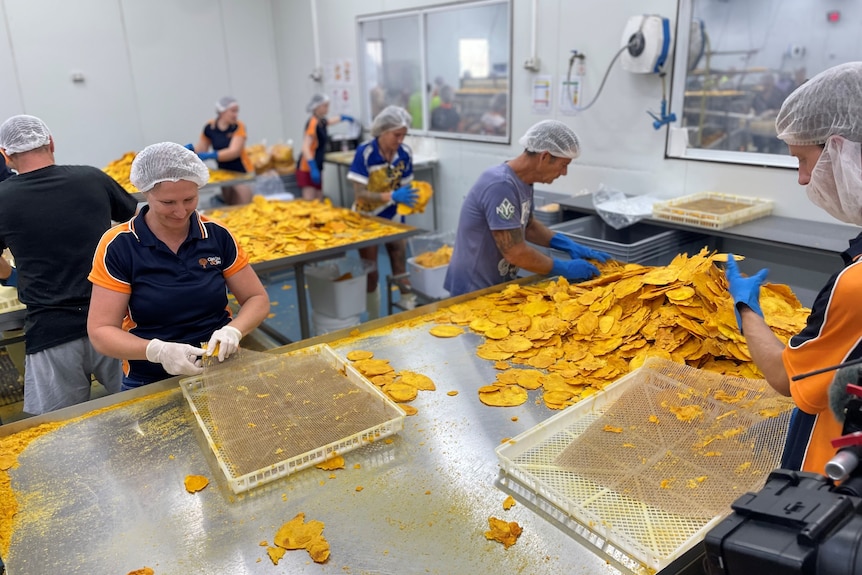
<box><xmin>775</xmin><ymin>62</ymin><xmax>862</xmax><ymax>146</ymax></box>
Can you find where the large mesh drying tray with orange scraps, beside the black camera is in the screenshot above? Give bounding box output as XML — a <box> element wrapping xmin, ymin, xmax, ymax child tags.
<box><xmin>496</xmin><ymin>358</ymin><xmax>792</xmax><ymax>574</ymax></box>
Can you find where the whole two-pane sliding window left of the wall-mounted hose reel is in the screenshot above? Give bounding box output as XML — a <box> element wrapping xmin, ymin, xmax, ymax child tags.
<box><xmin>359</xmin><ymin>0</ymin><xmax>511</xmax><ymax>142</ymax></box>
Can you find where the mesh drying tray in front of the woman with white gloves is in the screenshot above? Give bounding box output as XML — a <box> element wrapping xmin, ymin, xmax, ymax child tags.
<box><xmin>180</xmin><ymin>344</ymin><xmax>406</xmax><ymax>493</ymax></box>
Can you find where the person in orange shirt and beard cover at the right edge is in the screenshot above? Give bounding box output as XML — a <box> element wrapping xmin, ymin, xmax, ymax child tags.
<box><xmin>726</xmin><ymin>62</ymin><xmax>862</xmax><ymax>473</ymax></box>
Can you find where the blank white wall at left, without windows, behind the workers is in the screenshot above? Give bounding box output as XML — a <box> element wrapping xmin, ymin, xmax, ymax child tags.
<box><xmin>0</xmin><ymin>0</ymin><xmax>285</xmax><ymax>166</ymax></box>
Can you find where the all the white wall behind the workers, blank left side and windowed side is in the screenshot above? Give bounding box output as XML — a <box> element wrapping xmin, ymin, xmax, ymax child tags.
<box><xmin>0</xmin><ymin>0</ymin><xmax>844</xmax><ymax>229</ymax></box>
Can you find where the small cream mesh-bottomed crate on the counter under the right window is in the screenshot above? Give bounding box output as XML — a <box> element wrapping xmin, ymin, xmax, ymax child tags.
<box><xmin>653</xmin><ymin>192</ymin><xmax>774</xmax><ymax>230</ymax></box>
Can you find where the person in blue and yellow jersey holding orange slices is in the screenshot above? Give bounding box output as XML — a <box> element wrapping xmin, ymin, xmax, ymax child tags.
<box><xmin>347</xmin><ymin>106</ymin><xmax>418</xmax><ymax>319</ymax></box>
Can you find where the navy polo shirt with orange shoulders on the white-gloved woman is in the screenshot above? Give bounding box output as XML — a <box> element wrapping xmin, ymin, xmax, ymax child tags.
<box><xmin>89</xmin><ymin>206</ymin><xmax>248</xmax><ymax>383</ymax></box>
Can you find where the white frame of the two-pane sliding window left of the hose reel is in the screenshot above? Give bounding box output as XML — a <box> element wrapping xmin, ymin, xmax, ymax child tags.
<box><xmin>356</xmin><ymin>0</ymin><xmax>513</xmax><ymax>144</ymax></box>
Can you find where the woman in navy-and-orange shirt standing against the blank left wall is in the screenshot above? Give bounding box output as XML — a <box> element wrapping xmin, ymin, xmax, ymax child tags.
<box><xmin>191</xmin><ymin>96</ymin><xmax>254</xmax><ymax>205</ymax></box>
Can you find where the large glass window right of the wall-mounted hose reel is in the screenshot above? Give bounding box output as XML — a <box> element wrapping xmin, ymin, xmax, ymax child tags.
<box><xmin>668</xmin><ymin>0</ymin><xmax>862</xmax><ymax>167</ymax></box>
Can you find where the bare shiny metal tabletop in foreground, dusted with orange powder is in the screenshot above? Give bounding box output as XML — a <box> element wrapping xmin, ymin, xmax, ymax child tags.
<box><xmin>0</xmin><ymin>316</ymin><xmax>614</xmax><ymax>575</ymax></box>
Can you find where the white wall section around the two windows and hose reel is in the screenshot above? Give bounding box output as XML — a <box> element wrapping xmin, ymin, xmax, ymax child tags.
<box><xmin>286</xmin><ymin>0</ymin><xmax>834</xmax><ymax>229</ymax></box>
